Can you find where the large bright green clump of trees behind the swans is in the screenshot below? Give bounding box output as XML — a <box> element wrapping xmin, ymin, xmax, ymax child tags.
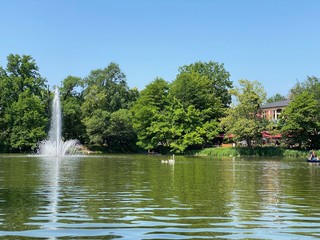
<box><xmin>132</xmin><ymin>62</ymin><xmax>232</xmax><ymax>153</ymax></box>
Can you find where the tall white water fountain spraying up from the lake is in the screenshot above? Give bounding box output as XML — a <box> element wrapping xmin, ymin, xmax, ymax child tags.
<box><xmin>37</xmin><ymin>87</ymin><xmax>79</xmax><ymax>156</ymax></box>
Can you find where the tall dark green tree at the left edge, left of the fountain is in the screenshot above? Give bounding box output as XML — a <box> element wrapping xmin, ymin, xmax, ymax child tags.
<box><xmin>0</xmin><ymin>54</ymin><xmax>49</xmax><ymax>151</ymax></box>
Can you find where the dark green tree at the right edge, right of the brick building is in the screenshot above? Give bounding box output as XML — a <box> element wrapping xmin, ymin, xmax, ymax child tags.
<box><xmin>280</xmin><ymin>91</ymin><xmax>320</xmax><ymax>148</ymax></box>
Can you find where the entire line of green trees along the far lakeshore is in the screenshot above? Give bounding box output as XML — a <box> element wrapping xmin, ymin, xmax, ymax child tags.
<box><xmin>0</xmin><ymin>54</ymin><xmax>320</xmax><ymax>153</ymax></box>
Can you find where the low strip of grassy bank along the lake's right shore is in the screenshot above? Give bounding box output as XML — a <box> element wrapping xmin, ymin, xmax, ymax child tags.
<box><xmin>193</xmin><ymin>147</ymin><xmax>307</xmax><ymax>158</ymax></box>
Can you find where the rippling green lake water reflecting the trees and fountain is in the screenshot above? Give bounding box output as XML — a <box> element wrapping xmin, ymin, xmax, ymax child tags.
<box><xmin>0</xmin><ymin>155</ymin><xmax>320</xmax><ymax>239</ymax></box>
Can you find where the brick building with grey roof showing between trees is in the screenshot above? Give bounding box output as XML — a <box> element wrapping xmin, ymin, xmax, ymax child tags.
<box><xmin>260</xmin><ymin>99</ymin><xmax>290</xmax><ymax>122</ymax></box>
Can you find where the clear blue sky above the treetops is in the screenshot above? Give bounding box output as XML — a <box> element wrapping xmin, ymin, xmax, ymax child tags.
<box><xmin>0</xmin><ymin>0</ymin><xmax>320</xmax><ymax>97</ymax></box>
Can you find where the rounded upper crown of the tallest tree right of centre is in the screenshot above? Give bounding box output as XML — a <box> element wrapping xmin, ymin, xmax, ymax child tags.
<box><xmin>170</xmin><ymin>61</ymin><xmax>232</xmax><ymax>120</ymax></box>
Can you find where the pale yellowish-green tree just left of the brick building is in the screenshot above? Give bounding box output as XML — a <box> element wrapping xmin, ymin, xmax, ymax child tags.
<box><xmin>221</xmin><ymin>80</ymin><xmax>266</xmax><ymax>147</ymax></box>
